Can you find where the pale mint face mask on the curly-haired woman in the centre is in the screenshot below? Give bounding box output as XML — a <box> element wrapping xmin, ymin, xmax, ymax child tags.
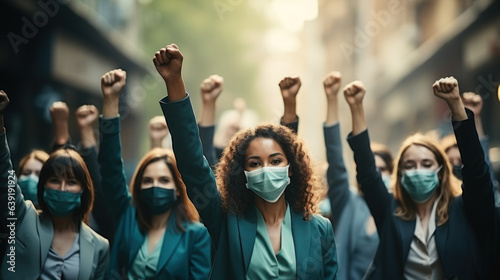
<box><xmin>245</xmin><ymin>165</ymin><xmax>290</xmax><ymax>203</ymax></box>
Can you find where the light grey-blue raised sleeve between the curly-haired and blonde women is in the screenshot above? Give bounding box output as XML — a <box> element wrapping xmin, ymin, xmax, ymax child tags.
<box><xmin>323</xmin><ymin>123</ymin><xmax>350</xmax><ymax>228</ymax></box>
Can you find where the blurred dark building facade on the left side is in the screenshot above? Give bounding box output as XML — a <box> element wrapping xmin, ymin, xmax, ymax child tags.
<box><xmin>0</xmin><ymin>0</ymin><xmax>147</xmax><ymax>166</ymax></box>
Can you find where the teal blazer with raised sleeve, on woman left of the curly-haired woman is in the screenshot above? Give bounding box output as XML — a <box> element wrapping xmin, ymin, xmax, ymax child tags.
<box><xmin>98</xmin><ymin>117</ymin><xmax>211</xmax><ymax>279</ymax></box>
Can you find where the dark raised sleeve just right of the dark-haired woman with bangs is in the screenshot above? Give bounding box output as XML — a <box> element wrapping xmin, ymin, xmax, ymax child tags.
<box><xmin>80</xmin><ymin>146</ymin><xmax>114</xmax><ymax>239</ymax></box>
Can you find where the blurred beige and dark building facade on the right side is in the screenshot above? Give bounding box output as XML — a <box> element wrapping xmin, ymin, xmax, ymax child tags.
<box><xmin>318</xmin><ymin>0</ymin><xmax>500</xmax><ymax>173</ymax></box>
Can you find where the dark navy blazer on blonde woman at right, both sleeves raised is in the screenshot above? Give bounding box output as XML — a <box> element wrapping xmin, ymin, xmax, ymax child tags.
<box><xmin>348</xmin><ymin>110</ymin><xmax>499</xmax><ymax>279</ymax></box>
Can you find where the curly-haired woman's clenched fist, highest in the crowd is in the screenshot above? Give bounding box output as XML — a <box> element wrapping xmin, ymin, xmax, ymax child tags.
<box><xmin>153</xmin><ymin>44</ymin><xmax>183</xmax><ymax>81</ymax></box>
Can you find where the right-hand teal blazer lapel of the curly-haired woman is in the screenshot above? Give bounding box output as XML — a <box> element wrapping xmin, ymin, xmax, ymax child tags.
<box><xmin>290</xmin><ymin>212</ymin><xmax>310</xmax><ymax>279</ymax></box>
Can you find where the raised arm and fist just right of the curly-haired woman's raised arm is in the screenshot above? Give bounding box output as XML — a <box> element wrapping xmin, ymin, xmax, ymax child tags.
<box><xmin>198</xmin><ymin>75</ymin><xmax>224</xmax><ymax>166</ymax></box>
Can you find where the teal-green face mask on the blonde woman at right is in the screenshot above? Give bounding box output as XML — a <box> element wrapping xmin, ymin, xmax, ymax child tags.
<box><xmin>401</xmin><ymin>167</ymin><xmax>441</xmax><ymax>203</ymax></box>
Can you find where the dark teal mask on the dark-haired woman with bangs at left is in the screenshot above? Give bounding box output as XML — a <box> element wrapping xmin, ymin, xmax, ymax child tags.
<box><xmin>43</xmin><ymin>187</ymin><xmax>82</xmax><ymax>217</ymax></box>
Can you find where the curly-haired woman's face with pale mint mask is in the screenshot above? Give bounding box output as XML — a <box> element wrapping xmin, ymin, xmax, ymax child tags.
<box><xmin>245</xmin><ymin>137</ymin><xmax>291</xmax><ymax>203</ymax></box>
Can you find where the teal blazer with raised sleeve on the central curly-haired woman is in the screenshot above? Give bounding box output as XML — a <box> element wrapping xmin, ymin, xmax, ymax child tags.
<box><xmin>160</xmin><ymin>96</ymin><xmax>337</xmax><ymax>279</ymax></box>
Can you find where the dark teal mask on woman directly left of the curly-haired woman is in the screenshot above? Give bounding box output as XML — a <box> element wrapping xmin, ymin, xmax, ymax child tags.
<box><xmin>139</xmin><ymin>187</ymin><xmax>177</xmax><ymax>215</ymax></box>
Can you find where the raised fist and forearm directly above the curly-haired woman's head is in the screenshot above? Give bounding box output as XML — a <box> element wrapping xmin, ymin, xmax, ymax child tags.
<box><xmin>278</xmin><ymin>77</ymin><xmax>302</xmax><ymax>133</ymax></box>
